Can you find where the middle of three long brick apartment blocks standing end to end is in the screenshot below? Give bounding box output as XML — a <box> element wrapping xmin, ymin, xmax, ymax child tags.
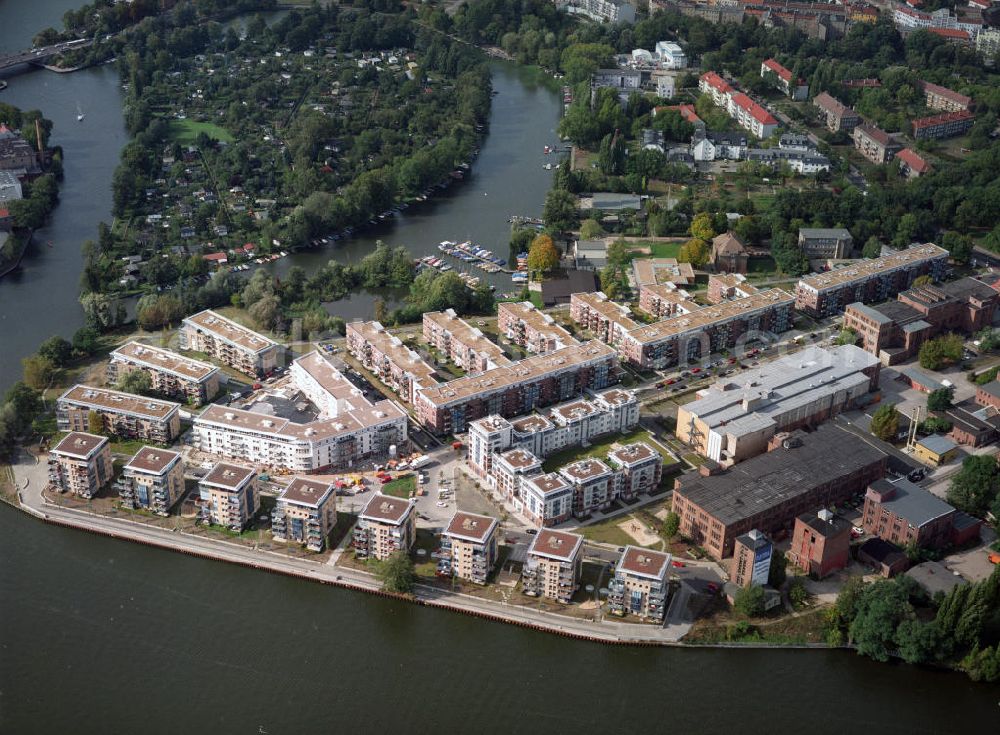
<box><xmin>618</xmin><ymin>288</ymin><xmax>795</xmax><ymax>370</ymax></box>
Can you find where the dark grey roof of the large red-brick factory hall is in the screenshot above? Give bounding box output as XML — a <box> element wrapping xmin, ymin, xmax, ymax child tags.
<box><xmin>675</xmin><ymin>423</ymin><xmax>886</xmax><ymax>526</ymax></box>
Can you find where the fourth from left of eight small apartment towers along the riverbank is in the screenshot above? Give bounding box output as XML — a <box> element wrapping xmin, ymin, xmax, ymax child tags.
<box><xmin>271</xmin><ymin>477</ymin><xmax>337</xmax><ymax>553</ymax></box>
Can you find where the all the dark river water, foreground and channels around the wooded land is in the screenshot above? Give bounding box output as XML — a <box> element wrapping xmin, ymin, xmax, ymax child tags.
<box><xmin>0</xmin><ymin>0</ymin><xmax>1000</xmax><ymax>735</ymax></box>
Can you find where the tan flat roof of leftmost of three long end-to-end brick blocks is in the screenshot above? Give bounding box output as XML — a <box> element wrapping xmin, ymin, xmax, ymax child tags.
<box><xmin>419</xmin><ymin>339</ymin><xmax>617</xmax><ymax>407</ymax></box>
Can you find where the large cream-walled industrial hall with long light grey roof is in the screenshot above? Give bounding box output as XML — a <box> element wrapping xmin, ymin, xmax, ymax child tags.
<box><xmin>676</xmin><ymin>345</ymin><xmax>881</xmax><ymax>465</ymax></box>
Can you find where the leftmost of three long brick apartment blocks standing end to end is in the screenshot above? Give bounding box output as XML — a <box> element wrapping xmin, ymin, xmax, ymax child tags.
<box><xmin>414</xmin><ymin>340</ymin><xmax>618</xmax><ymax>434</ymax></box>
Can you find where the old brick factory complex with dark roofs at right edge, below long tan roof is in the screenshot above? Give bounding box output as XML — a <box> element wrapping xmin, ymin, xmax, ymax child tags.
<box><xmin>844</xmin><ymin>278</ymin><xmax>1000</xmax><ymax>365</ymax></box>
